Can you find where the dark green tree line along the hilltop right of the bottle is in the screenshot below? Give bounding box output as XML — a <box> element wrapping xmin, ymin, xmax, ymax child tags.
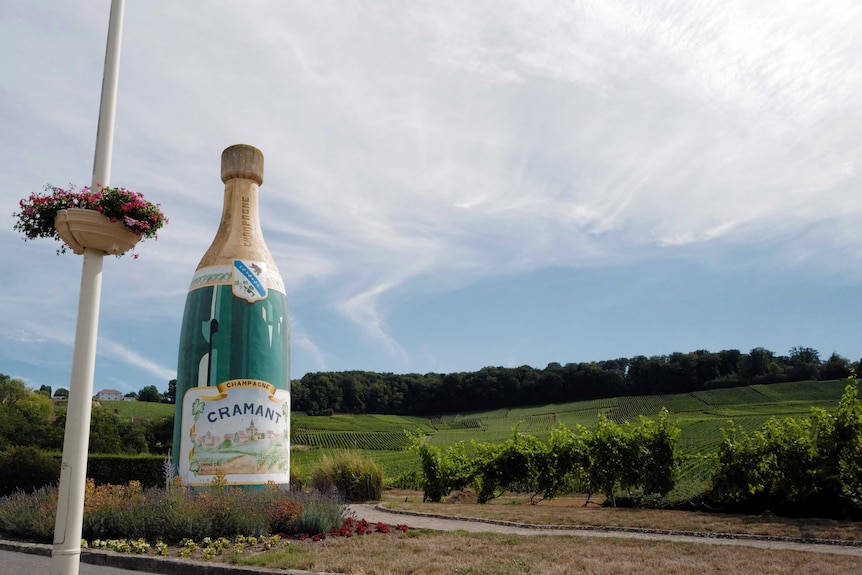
<box><xmin>291</xmin><ymin>347</ymin><xmax>859</xmax><ymax>415</ymax></box>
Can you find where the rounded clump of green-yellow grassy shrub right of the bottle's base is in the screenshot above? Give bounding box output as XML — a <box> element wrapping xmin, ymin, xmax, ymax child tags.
<box><xmin>311</xmin><ymin>451</ymin><xmax>383</xmax><ymax>501</ymax></box>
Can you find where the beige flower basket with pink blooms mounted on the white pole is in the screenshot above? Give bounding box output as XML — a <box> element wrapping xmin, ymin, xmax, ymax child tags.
<box><xmin>12</xmin><ymin>184</ymin><xmax>168</xmax><ymax>258</ymax></box>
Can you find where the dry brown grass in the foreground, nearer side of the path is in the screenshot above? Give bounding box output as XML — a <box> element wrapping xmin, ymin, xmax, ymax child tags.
<box><xmin>231</xmin><ymin>531</ymin><xmax>862</xmax><ymax>575</ymax></box>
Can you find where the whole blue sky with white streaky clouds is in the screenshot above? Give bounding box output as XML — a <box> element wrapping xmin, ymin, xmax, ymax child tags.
<box><xmin>0</xmin><ymin>0</ymin><xmax>862</xmax><ymax>392</ymax></box>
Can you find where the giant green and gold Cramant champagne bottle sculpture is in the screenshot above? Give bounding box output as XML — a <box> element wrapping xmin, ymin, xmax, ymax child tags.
<box><xmin>173</xmin><ymin>145</ymin><xmax>290</xmax><ymax>486</ymax></box>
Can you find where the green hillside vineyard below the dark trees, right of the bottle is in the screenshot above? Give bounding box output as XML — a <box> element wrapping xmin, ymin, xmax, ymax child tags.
<box><xmin>291</xmin><ymin>380</ymin><xmax>847</xmax><ymax>498</ymax></box>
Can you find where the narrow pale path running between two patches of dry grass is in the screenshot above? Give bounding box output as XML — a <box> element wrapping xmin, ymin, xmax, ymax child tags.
<box><xmin>348</xmin><ymin>504</ymin><xmax>862</xmax><ymax>557</ymax></box>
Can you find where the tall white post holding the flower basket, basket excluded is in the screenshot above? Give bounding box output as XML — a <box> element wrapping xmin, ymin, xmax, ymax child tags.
<box><xmin>51</xmin><ymin>0</ymin><xmax>125</xmax><ymax>575</ymax></box>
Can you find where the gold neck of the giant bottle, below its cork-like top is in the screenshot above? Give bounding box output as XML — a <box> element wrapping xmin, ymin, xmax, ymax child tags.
<box><xmin>198</xmin><ymin>178</ymin><xmax>277</xmax><ymax>270</ymax></box>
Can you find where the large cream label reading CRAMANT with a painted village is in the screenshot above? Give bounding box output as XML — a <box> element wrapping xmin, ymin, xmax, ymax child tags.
<box><xmin>178</xmin><ymin>379</ymin><xmax>290</xmax><ymax>485</ymax></box>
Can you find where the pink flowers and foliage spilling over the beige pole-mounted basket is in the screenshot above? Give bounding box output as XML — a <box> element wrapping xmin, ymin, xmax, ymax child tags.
<box><xmin>12</xmin><ymin>184</ymin><xmax>168</xmax><ymax>254</ymax></box>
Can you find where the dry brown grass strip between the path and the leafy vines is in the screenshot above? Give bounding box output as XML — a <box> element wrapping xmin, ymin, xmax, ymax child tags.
<box><xmin>384</xmin><ymin>491</ymin><xmax>862</xmax><ymax>541</ymax></box>
